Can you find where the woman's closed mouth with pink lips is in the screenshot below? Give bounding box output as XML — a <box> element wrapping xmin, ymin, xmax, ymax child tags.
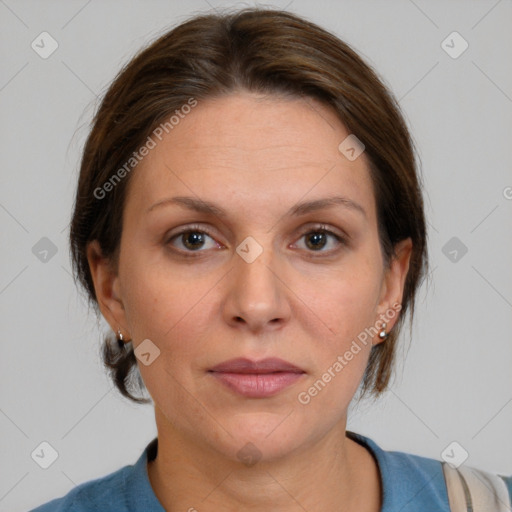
<box><xmin>208</xmin><ymin>358</ymin><xmax>306</xmax><ymax>398</ymax></box>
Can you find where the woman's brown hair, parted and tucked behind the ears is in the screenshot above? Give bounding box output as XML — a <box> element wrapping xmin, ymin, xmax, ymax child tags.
<box><xmin>70</xmin><ymin>8</ymin><xmax>427</xmax><ymax>402</ymax></box>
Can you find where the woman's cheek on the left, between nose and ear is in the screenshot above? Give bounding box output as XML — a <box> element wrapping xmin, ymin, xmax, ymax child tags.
<box><xmin>120</xmin><ymin>250</ymin><xmax>219</xmax><ymax>378</ymax></box>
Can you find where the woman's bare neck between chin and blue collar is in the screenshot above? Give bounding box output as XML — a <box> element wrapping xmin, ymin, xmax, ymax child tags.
<box><xmin>148</xmin><ymin>412</ymin><xmax>381</xmax><ymax>512</ymax></box>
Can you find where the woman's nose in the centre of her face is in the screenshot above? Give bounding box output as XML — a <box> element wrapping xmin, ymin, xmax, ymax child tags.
<box><xmin>224</xmin><ymin>242</ymin><xmax>291</xmax><ymax>333</ymax></box>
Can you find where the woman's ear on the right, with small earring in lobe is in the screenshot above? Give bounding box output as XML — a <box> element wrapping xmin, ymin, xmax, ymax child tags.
<box><xmin>377</xmin><ymin>238</ymin><xmax>412</xmax><ymax>343</ymax></box>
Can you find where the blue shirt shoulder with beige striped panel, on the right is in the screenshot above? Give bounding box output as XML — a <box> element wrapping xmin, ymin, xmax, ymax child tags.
<box><xmin>347</xmin><ymin>432</ymin><xmax>512</xmax><ymax>512</ymax></box>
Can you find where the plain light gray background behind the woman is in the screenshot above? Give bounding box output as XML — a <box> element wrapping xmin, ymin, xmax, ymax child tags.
<box><xmin>0</xmin><ymin>0</ymin><xmax>512</xmax><ymax>512</ymax></box>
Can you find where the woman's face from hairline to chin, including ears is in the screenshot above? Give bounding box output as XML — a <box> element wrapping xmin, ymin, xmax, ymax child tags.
<box><xmin>93</xmin><ymin>93</ymin><xmax>409</xmax><ymax>460</ymax></box>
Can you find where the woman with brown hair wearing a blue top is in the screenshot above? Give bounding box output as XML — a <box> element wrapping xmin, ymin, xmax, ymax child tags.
<box><xmin>30</xmin><ymin>5</ymin><xmax>512</xmax><ymax>512</ymax></box>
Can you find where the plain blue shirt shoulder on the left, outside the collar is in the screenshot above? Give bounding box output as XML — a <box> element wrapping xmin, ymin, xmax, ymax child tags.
<box><xmin>31</xmin><ymin>466</ymin><xmax>133</xmax><ymax>512</ymax></box>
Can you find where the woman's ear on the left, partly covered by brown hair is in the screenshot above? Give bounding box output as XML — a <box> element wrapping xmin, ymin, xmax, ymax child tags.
<box><xmin>87</xmin><ymin>240</ymin><xmax>129</xmax><ymax>338</ymax></box>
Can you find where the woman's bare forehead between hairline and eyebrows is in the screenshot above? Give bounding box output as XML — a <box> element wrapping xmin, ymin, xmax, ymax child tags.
<box><xmin>127</xmin><ymin>92</ymin><xmax>375</xmax><ymax>222</ymax></box>
